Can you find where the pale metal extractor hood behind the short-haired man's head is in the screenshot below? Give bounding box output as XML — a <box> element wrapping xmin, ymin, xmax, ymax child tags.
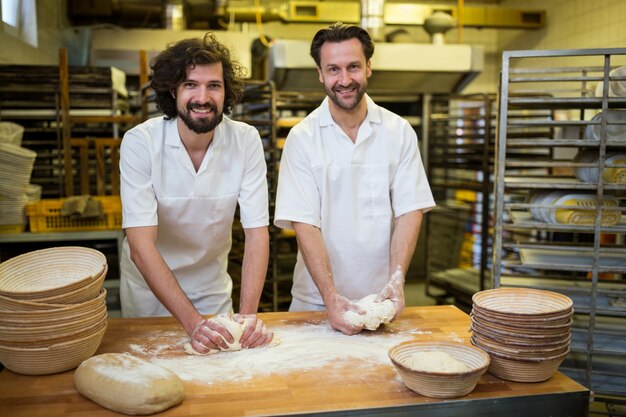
<box><xmin>268</xmin><ymin>39</ymin><xmax>484</xmax><ymax>94</ymax></box>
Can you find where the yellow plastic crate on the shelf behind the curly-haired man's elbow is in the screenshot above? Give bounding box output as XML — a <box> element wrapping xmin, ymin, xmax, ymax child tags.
<box><xmin>26</xmin><ymin>196</ymin><xmax>122</xmax><ymax>233</ymax></box>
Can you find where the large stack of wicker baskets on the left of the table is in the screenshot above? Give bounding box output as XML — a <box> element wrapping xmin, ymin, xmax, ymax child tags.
<box><xmin>0</xmin><ymin>247</ymin><xmax>108</xmax><ymax>375</ymax></box>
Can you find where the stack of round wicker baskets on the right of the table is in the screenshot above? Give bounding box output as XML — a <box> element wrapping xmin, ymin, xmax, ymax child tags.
<box><xmin>471</xmin><ymin>288</ymin><xmax>574</xmax><ymax>382</ymax></box>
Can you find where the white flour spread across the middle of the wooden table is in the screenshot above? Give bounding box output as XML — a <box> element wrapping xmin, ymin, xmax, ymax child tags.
<box><xmin>141</xmin><ymin>322</ymin><xmax>413</xmax><ymax>385</ymax></box>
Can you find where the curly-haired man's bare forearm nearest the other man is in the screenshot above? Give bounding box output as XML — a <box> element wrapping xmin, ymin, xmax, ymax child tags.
<box><xmin>239</xmin><ymin>227</ymin><xmax>269</xmax><ymax>314</ymax></box>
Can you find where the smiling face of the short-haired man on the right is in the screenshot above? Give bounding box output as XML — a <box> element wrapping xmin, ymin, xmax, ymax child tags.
<box><xmin>317</xmin><ymin>38</ymin><xmax>372</xmax><ymax>111</ymax></box>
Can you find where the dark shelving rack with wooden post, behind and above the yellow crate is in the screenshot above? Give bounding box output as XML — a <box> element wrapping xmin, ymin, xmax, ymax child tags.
<box><xmin>0</xmin><ymin>55</ymin><xmax>138</xmax><ymax>198</ymax></box>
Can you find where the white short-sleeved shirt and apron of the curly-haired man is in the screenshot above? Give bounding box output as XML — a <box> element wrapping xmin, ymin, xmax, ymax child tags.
<box><xmin>120</xmin><ymin>117</ymin><xmax>269</xmax><ymax>315</ymax></box>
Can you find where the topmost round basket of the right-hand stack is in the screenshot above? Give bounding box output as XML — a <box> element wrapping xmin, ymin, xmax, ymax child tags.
<box><xmin>472</xmin><ymin>288</ymin><xmax>573</xmax><ymax>318</ymax></box>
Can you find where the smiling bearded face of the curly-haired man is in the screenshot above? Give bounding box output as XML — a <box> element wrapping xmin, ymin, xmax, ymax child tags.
<box><xmin>176</xmin><ymin>62</ymin><xmax>225</xmax><ymax>134</ymax></box>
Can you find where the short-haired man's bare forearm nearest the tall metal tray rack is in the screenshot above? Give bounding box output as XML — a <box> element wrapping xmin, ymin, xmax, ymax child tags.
<box><xmin>389</xmin><ymin>210</ymin><xmax>423</xmax><ymax>276</ymax></box>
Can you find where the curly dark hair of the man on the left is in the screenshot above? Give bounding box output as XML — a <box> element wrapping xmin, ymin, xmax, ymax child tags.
<box><xmin>150</xmin><ymin>33</ymin><xmax>245</xmax><ymax>119</ymax></box>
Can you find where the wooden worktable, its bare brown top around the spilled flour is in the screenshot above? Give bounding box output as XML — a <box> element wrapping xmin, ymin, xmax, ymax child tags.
<box><xmin>0</xmin><ymin>306</ymin><xmax>589</xmax><ymax>417</ymax></box>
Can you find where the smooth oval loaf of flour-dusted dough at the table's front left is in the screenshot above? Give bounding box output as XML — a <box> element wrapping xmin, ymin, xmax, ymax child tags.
<box><xmin>74</xmin><ymin>353</ymin><xmax>184</xmax><ymax>415</ymax></box>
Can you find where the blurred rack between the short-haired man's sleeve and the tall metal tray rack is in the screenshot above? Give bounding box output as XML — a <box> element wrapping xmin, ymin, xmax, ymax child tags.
<box><xmin>426</xmin><ymin>94</ymin><xmax>496</xmax><ymax>310</ymax></box>
